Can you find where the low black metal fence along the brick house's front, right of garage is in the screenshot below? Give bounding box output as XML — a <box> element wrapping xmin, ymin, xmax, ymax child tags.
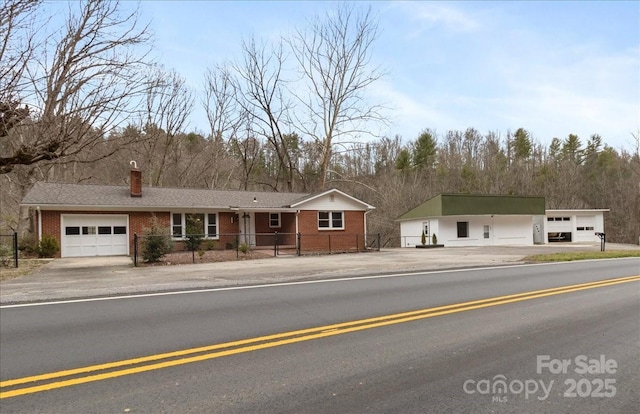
<box><xmin>133</xmin><ymin>232</ymin><xmax>380</xmax><ymax>266</ymax></box>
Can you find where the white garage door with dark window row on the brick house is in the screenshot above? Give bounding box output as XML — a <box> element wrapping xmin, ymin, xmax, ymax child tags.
<box><xmin>61</xmin><ymin>214</ymin><xmax>129</xmax><ymax>257</ymax></box>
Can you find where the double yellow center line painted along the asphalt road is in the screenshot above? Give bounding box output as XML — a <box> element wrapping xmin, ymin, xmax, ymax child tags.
<box><xmin>0</xmin><ymin>275</ymin><xmax>640</xmax><ymax>399</ymax></box>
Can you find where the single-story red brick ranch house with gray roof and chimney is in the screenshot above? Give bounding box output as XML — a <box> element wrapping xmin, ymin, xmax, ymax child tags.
<box><xmin>21</xmin><ymin>168</ymin><xmax>375</xmax><ymax>257</ymax></box>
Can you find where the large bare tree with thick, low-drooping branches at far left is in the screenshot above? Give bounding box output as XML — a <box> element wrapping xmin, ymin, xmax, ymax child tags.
<box><xmin>0</xmin><ymin>0</ymin><xmax>149</xmax><ymax>173</ymax></box>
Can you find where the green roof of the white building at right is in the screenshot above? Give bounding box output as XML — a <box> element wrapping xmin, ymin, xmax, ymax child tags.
<box><xmin>398</xmin><ymin>194</ymin><xmax>545</xmax><ymax>220</ymax></box>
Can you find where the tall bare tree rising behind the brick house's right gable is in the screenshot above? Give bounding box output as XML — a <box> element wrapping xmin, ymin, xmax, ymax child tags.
<box><xmin>289</xmin><ymin>4</ymin><xmax>383</xmax><ymax>188</ymax></box>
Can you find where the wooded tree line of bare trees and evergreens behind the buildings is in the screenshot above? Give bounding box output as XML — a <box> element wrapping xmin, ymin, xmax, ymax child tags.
<box><xmin>0</xmin><ymin>0</ymin><xmax>640</xmax><ymax>246</ymax></box>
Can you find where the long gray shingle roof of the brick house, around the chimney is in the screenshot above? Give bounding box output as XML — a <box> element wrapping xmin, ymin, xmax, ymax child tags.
<box><xmin>22</xmin><ymin>182</ymin><xmax>310</xmax><ymax>210</ymax></box>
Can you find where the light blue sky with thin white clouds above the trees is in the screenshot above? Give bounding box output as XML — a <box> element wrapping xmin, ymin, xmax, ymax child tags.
<box><xmin>126</xmin><ymin>1</ymin><xmax>640</xmax><ymax>150</ymax></box>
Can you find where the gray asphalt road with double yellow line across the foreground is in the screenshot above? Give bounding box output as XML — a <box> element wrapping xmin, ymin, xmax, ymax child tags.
<box><xmin>0</xmin><ymin>259</ymin><xmax>640</xmax><ymax>413</ymax></box>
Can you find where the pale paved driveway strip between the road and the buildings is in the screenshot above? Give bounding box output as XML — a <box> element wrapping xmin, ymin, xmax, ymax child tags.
<box><xmin>0</xmin><ymin>244</ymin><xmax>640</xmax><ymax>304</ymax></box>
